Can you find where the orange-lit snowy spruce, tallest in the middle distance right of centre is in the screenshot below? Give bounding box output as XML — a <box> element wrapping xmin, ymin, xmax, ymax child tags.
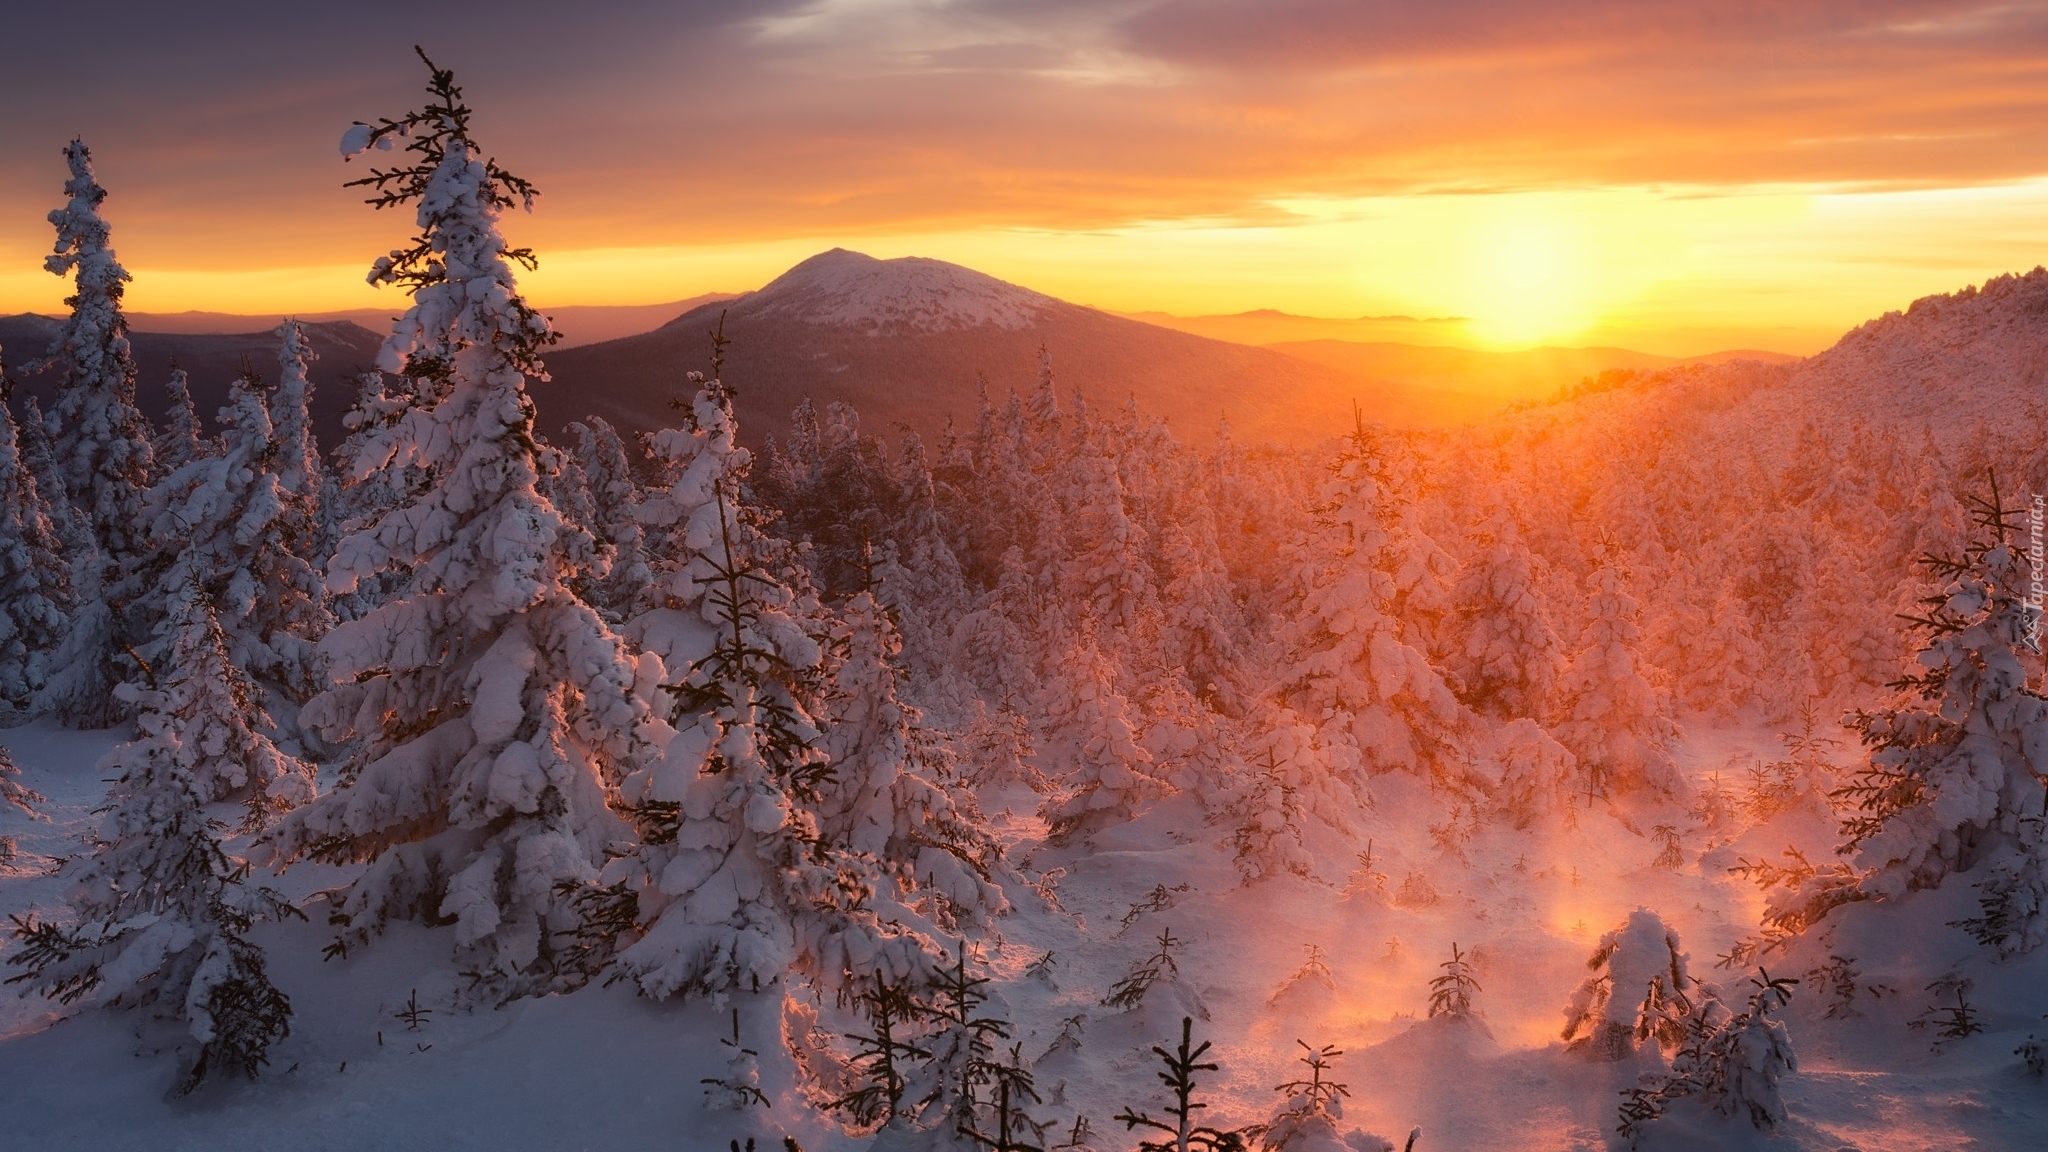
<box><xmin>1280</xmin><ymin>409</ymin><xmax>1468</xmax><ymax>787</ymax></box>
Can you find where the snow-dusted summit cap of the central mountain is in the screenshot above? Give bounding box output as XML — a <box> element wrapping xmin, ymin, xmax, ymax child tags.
<box><xmin>733</xmin><ymin>248</ymin><xmax>1059</xmax><ymax>336</ymax></box>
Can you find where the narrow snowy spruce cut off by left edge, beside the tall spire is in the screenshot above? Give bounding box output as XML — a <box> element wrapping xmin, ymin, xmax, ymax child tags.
<box><xmin>0</xmin><ymin>367</ymin><xmax>72</xmax><ymax>715</ymax></box>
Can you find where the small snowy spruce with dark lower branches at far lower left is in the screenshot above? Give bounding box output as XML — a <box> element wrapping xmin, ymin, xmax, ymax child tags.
<box><xmin>8</xmin><ymin>592</ymin><xmax>299</xmax><ymax>1091</ymax></box>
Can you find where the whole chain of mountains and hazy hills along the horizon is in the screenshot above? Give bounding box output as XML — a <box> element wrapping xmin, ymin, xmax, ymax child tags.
<box><xmin>0</xmin><ymin>250</ymin><xmax>1794</xmax><ymax>445</ymax></box>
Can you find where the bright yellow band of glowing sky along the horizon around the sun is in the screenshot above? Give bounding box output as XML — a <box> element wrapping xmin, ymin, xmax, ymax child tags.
<box><xmin>0</xmin><ymin>180</ymin><xmax>2048</xmax><ymax>357</ymax></box>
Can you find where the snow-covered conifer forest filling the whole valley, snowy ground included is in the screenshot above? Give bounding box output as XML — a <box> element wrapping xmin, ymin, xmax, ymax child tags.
<box><xmin>0</xmin><ymin>51</ymin><xmax>2048</xmax><ymax>1152</ymax></box>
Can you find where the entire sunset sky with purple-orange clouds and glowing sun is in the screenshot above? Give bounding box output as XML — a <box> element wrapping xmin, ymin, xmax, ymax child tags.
<box><xmin>0</xmin><ymin>0</ymin><xmax>2048</xmax><ymax>355</ymax></box>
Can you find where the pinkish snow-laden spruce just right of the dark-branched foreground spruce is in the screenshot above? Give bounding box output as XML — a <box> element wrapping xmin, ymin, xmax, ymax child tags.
<box><xmin>817</xmin><ymin>592</ymin><xmax>1008</xmax><ymax>929</ymax></box>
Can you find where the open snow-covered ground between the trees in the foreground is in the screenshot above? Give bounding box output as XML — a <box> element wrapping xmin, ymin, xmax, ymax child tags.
<box><xmin>0</xmin><ymin>722</ymin><xmax>2048</xmax><ymax>1152</ymax></box>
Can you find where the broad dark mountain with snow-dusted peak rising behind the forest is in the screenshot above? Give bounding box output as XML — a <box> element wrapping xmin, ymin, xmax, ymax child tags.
<box><xmin>535</xmin><ymin>248</ymin><xmax>1399</xmax><ymax>443</ymax></box>
